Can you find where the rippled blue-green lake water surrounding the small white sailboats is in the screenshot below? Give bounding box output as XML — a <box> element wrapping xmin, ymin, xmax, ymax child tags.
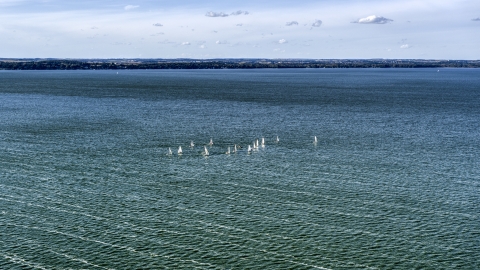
<box><xmin>0</xmin><ymin>69</ymin><xmax>480</xmax><ymax>269</ymax></box>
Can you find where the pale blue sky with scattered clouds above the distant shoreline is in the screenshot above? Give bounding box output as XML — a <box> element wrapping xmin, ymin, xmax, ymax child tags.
<box><xmin>0</xmin><ymin>0</ymin><xmax>480</xmax><ymax>59</ymax></box>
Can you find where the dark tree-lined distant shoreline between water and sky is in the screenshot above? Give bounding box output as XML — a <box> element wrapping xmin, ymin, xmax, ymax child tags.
<box><xmin>0</xmin><ymin>58</ymin><xmax>480</xmax><ymax>70</ymax></box>
